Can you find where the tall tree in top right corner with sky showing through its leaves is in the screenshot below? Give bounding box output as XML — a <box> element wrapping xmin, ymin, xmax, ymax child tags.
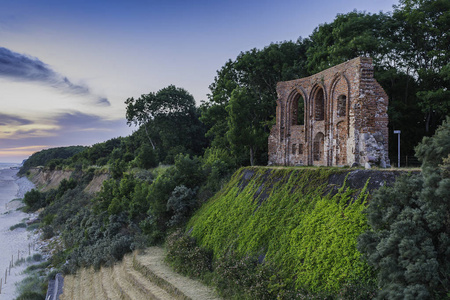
<box><xmin>389</xmin><ymin>0</ymin><xmax>450</xmax><ymax>134</ymax></box>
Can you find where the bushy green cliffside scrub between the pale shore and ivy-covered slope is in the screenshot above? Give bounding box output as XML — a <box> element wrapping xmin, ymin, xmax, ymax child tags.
<box><xmin>20</xmin><ymin>154</ymin><xmax>232</xmax><ymax>273</ymax></box>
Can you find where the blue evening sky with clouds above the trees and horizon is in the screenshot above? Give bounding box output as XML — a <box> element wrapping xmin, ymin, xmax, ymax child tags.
<box><xmin>0</xmin><ymin>0</ymin><xmax>398</xmax><ymax>162</ymax></box>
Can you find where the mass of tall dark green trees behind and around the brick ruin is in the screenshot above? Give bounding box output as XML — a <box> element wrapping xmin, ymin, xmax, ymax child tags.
<box><xmin>201</xmin><ymin>0</ymin><xmax>450</xmax><ymax>164</ymax></box>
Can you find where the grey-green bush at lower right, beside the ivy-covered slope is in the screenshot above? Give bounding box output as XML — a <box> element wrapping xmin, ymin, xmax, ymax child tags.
<box><xmin>359</xmin><ymin>118</ymin><xmax>450</xmax><ymax>299</ymax></box>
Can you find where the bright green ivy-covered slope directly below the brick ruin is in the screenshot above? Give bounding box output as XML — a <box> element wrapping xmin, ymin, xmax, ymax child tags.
<box><xmin>187</xmin><ymin>167</ymin><xmax>396</xmax><ymax>292</ymax></box>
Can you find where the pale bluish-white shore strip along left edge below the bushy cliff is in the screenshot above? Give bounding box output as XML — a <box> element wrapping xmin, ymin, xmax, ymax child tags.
<box><xmin>0</xmin><ymin>163</ymin><xmax>38</xmax><ymax>300</ymax></box>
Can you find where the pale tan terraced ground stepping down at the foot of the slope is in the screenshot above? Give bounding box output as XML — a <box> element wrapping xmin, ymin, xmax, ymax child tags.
<box><xmin>61</xmin><ymin>247</ymin><xmax>221</xmax><ymax>300</ymax></box>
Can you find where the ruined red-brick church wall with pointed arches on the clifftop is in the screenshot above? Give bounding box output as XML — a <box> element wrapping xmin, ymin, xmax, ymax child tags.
<box><xmin>269</xmin><ymin>57</ymin><xmax>390</xmax><ymax>168</ymax></box>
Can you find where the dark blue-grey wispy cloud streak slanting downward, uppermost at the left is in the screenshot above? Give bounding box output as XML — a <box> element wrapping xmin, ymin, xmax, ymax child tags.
<box><xmin>0</xmin><ymin>47</ymin><xmax>111</xmax><ymax>106</ymax></box>
